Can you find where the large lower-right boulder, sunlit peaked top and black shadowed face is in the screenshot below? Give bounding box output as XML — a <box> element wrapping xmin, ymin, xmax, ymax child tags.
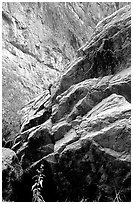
<box><xmin>56</xmin><ymin>94</ymin><xmax>131</xmax><ymax>201</ymax></box>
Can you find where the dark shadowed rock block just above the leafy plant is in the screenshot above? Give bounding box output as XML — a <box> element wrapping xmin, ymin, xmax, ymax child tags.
<box><xmin>17</xmin><ymin>122</ymin><xmax>54</xmax><ymax>169</ymax></box>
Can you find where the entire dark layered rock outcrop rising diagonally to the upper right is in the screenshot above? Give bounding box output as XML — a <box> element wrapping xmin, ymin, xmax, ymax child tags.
<box><xmin>2</xmin><ymin>3</ymin><xmax>131</xmax><ymax>202</ymax></box>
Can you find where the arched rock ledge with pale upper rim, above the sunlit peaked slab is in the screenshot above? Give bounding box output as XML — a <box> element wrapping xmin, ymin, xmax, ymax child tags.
<box><xmin>52</xmin><ymin>68</ymin><xmax>131</xmax><ymax>122</ymax></box>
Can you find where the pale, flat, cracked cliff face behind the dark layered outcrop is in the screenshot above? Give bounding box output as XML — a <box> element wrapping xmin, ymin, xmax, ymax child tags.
<box><xmin>2</xmin><ymin>2</ymin><xmax>127</xmax><ymax>139</ymax></box>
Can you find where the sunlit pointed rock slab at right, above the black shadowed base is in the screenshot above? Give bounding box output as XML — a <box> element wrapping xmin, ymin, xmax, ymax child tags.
<box><xmin>56</xmin><ymin>94</ymin><xmax>131</xmax><ymax>157</ymax></box>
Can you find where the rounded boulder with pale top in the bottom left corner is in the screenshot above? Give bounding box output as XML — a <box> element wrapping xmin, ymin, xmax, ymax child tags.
<box><xmin>2</xmin><ymin>148</ymin><xmax>23</xmax><ymax>201</ymax></box>
